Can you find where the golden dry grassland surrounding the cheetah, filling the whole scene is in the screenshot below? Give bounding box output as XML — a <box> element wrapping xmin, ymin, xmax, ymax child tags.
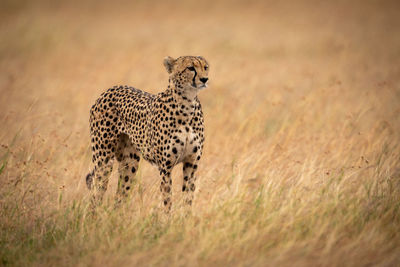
<box><xmin>0</xmin><ymin>0</ymin><xmax>400</xmax><ymax>266</ymax></box>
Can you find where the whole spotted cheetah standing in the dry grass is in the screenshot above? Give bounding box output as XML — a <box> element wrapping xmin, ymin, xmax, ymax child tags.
<box><xmin>86</xmin><ymin>56</ymin><xmax>209</xmax><ymax>212</ymax></box>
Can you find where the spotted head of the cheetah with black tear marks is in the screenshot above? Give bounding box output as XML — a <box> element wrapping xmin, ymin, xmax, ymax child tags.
<box><xmin>164</xmin><ymin>56</ymin><xmax>209</xmax><ymax>93</ymax></box>
